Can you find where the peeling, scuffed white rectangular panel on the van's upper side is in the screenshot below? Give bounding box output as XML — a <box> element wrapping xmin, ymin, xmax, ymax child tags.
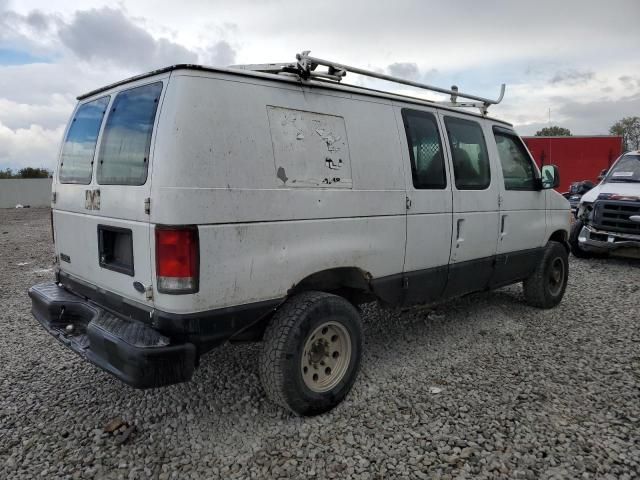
<box><xmin>267</xmin><ymin>106</ymin><xmax>353</xmax><ymax>188</ymax></box>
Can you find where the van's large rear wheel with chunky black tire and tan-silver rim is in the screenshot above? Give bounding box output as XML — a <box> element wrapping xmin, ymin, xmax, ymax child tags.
<box><xmin>259</xmin><ymin>292</ymin><xmax>363</xmax><ymax>415</ymax></box>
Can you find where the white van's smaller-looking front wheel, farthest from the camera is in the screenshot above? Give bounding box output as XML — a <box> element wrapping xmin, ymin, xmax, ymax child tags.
<box><xmin>523</xmin><ymin>241</ymin><xmax>569</xmax><ymax>308</ymax></box>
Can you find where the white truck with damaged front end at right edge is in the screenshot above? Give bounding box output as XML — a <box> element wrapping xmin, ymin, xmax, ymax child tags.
<box><xmin>570</xmin><ymin>151</ymin><xmax>640</xmax><ymax>258</ymax></box>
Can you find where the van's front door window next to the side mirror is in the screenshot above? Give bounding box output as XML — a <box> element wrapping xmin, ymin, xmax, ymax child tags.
<box><xmin>493</xmin><ymin>127</ymin><xmax>537</xmax><ymax>190</ymax></box>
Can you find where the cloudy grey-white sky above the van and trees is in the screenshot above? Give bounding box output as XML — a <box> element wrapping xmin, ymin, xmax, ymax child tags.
<box><xmin>0</xmin><ymin>0</ymin><xmax>640</xmax><ymax>169</ymax></box>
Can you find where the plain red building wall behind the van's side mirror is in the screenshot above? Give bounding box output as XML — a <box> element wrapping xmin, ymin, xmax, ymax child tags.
<box><xmin>522</xmin><ymin>135</ymin><xmax>622</xmax><ymax>192</ymax></box>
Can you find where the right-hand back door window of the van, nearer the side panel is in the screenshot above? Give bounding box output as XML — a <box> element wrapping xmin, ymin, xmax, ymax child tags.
<box><xmin>98</xmin><ymin>82</ymin><xmax>162</xmax><ymax>185</ymax></box>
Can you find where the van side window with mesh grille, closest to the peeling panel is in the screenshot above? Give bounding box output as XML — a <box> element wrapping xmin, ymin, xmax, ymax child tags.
<box><xmin>402</xmin><ymin>108</ymin><xmax>447</xmax><ymax>189</ymax></box>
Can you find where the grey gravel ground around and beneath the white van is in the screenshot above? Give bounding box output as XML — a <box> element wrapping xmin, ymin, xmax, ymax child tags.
<box><xmin>0</xmin><ymin>209</ymin><xmax>640</xmax><ymax>479</ymax></box>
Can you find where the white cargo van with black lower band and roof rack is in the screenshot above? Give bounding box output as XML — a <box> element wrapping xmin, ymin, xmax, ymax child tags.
<box><xmin>29</xmin><ymin>52</ymin><xmax>570</xmax><ymax>415</ymax></box>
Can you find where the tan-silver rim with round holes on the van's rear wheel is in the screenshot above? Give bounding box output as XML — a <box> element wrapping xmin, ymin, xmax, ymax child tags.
<box><xmin>300</xmin><ymin>322</ymin><xmax>351</xmax><ymax>393</ymax></box>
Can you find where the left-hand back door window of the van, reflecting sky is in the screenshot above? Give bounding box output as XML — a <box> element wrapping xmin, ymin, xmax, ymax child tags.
<box><xmin>58</xmin><ymin>97</ymin><xmax>109</xmax><ymax>184</ymax></box>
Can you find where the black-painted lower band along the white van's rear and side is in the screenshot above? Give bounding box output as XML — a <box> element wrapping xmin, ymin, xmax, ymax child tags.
<box><xmin>58</xmin><ymin>247</ymin><xmax>544</xmax><ymax>354</ymax></box>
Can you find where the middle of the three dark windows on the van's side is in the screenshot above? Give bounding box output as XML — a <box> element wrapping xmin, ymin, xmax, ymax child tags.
<box><xmin>444</xmin><ymin>117</ymin><xmax>491</xmax><ymax>190</ymax></box>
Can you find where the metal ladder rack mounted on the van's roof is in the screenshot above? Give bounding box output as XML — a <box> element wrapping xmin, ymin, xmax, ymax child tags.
<box><xmin>229</xmin><ymin>50</ymin><xmax>505</xmax><ymax>115</ymax></box>
